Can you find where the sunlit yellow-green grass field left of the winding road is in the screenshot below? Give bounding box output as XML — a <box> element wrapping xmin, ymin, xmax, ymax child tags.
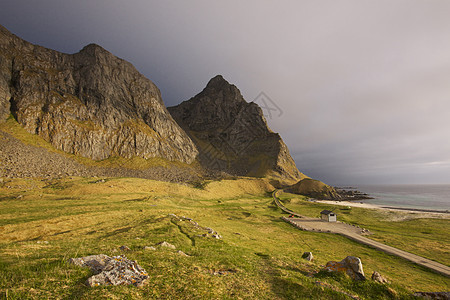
<box><xmin>0</xmin><ymin>178</ymin><xmax>449</xmax><ymax>299</ymax></box>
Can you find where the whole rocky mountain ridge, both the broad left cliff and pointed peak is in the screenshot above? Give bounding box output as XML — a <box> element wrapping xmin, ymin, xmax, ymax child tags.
<box><xmin>0</xmin><ymin>26</ymin><xmax>305</xmax><ymax>184</ymax></box>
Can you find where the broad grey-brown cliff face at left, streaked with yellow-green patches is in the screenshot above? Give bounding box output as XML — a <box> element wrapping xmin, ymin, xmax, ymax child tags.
<box><xmin>0</xmin><ymin>26</ymin><xmax>198</xmax><ymax>163</ymax></box>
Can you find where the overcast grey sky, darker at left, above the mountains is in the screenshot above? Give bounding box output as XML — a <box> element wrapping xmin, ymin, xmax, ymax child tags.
<box><xmin>0</xmin><ymin>0</ymin><xmax>450</xmax><ymax>185</ymax></box>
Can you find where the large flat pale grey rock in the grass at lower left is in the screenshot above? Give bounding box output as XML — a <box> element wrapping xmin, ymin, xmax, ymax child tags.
<box><xmin>69</xmin><ymin>254</ymin><xmax>148</xmax><ymax>286</ymax></box>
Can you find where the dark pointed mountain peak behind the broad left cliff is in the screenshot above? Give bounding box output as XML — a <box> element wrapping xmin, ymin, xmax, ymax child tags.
<box><xmin>168</xmin><ymin>75</ymin><xmax>305</xmax><ymax>181</ymax></box>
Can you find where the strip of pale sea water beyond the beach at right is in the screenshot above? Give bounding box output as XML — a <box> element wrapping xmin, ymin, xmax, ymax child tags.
<box><xmin>357</xmin><ymin>184</ymin><xmax>450</xmax><ymax>211</ymax></box>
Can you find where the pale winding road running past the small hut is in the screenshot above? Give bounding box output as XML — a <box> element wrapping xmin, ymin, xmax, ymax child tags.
<box><xmin>272</xmin><ymin>190</ymin><xmax>450</xmax><ymax>277</ymax></box>
